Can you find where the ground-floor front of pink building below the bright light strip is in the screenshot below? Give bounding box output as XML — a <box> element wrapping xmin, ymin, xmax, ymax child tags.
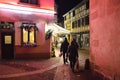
<box><xmin>0</xmin><ymin>2</ymin><xmax>54</xmax><ymax>59</ymax></box>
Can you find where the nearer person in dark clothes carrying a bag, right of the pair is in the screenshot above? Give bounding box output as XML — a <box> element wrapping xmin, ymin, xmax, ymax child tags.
<box><xmin>68</xmin><ymin>39</ymin><xmax>78</xmax><ymax>72</ymax></box>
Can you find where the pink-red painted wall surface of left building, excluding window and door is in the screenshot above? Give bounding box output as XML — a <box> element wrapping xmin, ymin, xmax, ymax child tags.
<box><xmin>0</xmin><ymin>0</ymin><xmax>54</xmax><ymax>59</ymax></box>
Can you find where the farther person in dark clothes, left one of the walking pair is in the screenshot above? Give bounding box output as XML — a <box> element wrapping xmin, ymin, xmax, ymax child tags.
<box><xmin>60</xmin><ymin>38</ymin><xmax>69</xmax><ymax>64</ymax></box>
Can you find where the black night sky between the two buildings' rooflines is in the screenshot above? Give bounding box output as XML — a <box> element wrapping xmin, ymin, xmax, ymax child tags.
<box><xmin>55</xmin><ymin>0</ymin><xmax>82</xmax><ymax>22</ymax></box>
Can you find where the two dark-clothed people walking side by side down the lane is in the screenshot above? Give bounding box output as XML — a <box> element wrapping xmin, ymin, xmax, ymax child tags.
<box><xmin>60</xmin><ymin>38</ymin><xmax>78</xmax><ymax>71</ymax></box>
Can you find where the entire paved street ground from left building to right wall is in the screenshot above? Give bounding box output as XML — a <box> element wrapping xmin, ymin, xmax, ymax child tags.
<box><xmin>0</xmin><ymin>49</ymin><xmax>96</xmax><ymax>80</ymax></box>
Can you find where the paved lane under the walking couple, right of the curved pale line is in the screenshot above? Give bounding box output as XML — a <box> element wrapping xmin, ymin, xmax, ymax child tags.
<box><xmin>54</xmin><ymin>47</ymin><xmax>94</xmax><ymax>80</ymax></box>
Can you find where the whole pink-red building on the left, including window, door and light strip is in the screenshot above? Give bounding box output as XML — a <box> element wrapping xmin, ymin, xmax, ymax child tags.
<box><xmin>0</xmin><ymin>0</ymin><xmax>55</xmax><ymax>59</ymax></box>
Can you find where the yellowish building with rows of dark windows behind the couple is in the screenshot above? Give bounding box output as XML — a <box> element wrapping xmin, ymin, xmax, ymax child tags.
<box><xmin>63</xmin><ymin>0</ymin><xmax>89</xmax><ymax>49</ymax></box>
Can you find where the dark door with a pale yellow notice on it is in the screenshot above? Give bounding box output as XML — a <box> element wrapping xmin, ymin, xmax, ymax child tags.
<box><xmin>1</xmin><ymin>31</ymin><xmax>14</xmax><ymax>59</ymax></box>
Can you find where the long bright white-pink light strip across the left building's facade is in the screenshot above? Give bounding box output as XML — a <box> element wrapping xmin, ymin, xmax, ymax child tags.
<box><xmin>0</xmin><ymin>4</ymin><xmax>55</xmax><ymax>15</ymax></box>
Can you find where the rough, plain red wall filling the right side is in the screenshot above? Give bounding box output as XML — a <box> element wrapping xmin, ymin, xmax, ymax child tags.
<box><xmin>90</xmin><ymin>0</ymin><xmax>120</xmax><ymax>80</ymax></box>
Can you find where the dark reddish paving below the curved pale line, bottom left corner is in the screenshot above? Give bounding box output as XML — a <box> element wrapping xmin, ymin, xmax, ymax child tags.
<box><xmin>0</xmin><ymin>67</ymin><xmax>57</xmax><ymax>80</ymax></box>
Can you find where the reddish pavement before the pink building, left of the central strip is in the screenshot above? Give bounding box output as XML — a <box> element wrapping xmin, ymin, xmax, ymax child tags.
<box><xmin>0</xmin><ymin>57</ymin><xmax>60</xmax><ymax>80</ymax></box>
